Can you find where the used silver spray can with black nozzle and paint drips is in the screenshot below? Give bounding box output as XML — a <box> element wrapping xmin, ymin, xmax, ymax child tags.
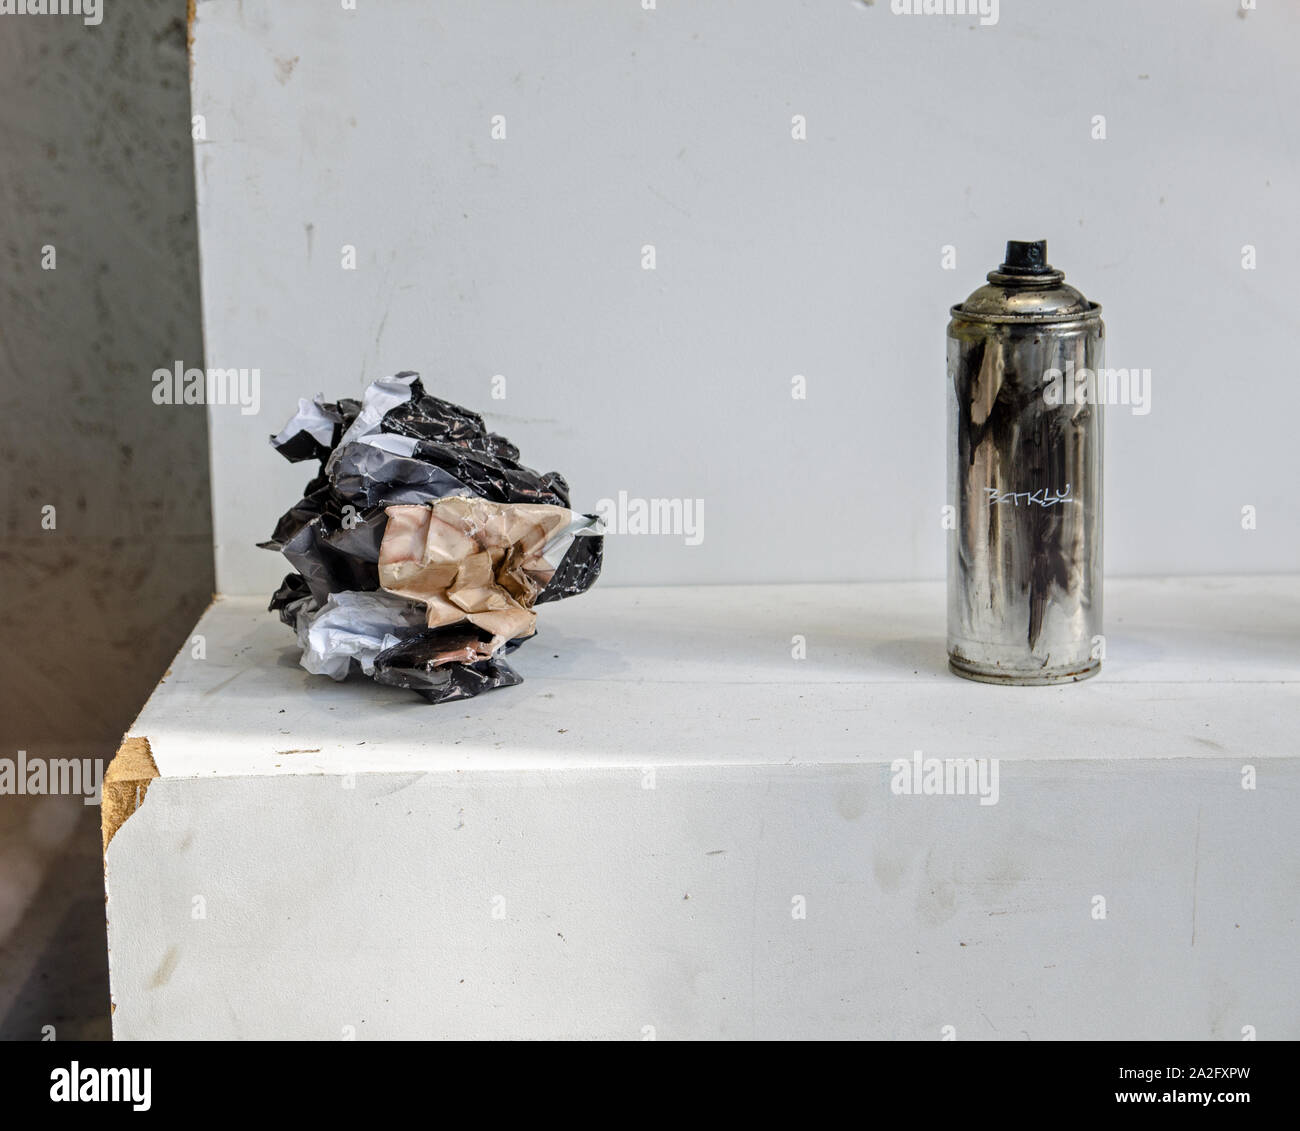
<box><xmin>948</xmin><ymin>239</ymin><xmax>1105</xmax><ymax>684</ymax></box>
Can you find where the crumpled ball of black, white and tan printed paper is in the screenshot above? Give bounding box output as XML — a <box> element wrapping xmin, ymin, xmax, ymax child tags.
<box><xmin>267</xmin><ymin>373</ymin><xmax>605</xmax><ymax>703</ymax></box>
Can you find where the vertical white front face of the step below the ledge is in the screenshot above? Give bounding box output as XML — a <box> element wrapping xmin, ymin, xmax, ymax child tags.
<box><xmin>107</xmin><ymin>759</ymin><xmax>1300</xmax><ymax>1054</ymax></box>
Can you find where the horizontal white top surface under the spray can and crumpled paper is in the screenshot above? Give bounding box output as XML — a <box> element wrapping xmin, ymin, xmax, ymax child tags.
<box><xmin>130</xmin><ymin>577</ymin><xmax>1300</xmax><ymax>777</ymax></box>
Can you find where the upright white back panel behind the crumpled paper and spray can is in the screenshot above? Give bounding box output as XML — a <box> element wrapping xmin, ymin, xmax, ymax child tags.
<box><xmin>192</xmin><ymin>0</ymin><xmax>1300</xmax><ymax>593</ymax></box>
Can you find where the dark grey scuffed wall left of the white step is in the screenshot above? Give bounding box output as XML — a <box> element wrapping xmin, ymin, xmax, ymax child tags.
<box><xmin>0</xmin><ymin>0</ymin><xmax>213</xmax><ymax>1039</ymax></box>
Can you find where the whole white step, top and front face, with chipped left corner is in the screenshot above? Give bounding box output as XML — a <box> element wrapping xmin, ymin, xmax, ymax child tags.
<box><xmin>107</xmin><ymin>577</ymin><xmax>1300</xmax><ymax>1040</ymax></box>
